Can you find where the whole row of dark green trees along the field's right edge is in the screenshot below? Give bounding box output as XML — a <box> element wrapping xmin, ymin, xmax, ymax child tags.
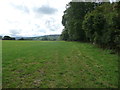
<box><xmin>61</xmin><ymin>2</ymin><xmax>120</xmax><ymax>51</ymax></box>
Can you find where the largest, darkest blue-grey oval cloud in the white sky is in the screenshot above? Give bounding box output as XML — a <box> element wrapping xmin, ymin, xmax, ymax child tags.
<box><xmin>34</xmin><ymin>5</ymin><xmax>58</xmax><ymax>15</ymax></box>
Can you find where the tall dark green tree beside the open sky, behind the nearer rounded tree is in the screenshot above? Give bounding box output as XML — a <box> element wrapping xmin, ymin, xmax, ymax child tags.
<box><xmin>62</xmin><ymin>2</ymin><xmax>97</xmax><ymax>41</ymax></box>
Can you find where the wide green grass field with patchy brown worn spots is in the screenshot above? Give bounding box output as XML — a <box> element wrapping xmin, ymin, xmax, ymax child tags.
<box><xmin>2</xmin><ymin>41</ymin><xmax>118</xmax><ymax>88</ymax></box>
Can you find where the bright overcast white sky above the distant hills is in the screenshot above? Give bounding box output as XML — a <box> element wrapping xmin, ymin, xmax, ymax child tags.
<box><xmin>0</xmin><ymin>0</ymin><xmax>71</xmax><ymax>37</ymax></box>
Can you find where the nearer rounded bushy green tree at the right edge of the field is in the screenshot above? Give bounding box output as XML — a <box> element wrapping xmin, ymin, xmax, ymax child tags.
<box><xmin>82</xmin><ymin>3</ymin><xmax>120</xmax><ymax>50</ymax></box>
